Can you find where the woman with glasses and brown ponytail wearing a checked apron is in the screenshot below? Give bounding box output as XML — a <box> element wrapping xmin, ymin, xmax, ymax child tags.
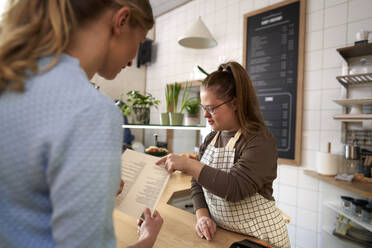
<box><xmin>158</xmin><ymin>62</ymin><xmax>290</xmax><ymax>247</ymax></box>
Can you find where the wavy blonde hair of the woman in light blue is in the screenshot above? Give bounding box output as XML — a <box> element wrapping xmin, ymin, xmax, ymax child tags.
<box><xmin>0</xmin><ymin>0</ymin><xmax>154</xmax><ymax>94</ymax></box>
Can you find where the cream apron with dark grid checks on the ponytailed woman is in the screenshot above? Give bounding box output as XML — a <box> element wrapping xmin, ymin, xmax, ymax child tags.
<box><xmin>200</xmin><ymin>130</ymin><xmax>290</xmax><ymax>247</ymax></box>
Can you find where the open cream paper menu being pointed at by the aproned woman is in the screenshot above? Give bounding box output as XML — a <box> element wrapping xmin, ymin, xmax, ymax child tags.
<box><xmin>115</xmin><ymin>149</ymin><xmax>169</xmax><ymax>218</ymax></box>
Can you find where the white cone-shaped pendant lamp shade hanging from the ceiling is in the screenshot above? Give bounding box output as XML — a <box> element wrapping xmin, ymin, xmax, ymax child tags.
<box><xmin>178</xmin><ymin>16</ymin><xmax>217</xmax><ymax>49</ymax></box>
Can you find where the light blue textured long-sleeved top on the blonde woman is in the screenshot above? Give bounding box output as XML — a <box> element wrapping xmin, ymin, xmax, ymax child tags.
<box><xmin>0</xmin><ymin>55</ymin><xmax>123</xmax><ymax>248</ymax></box>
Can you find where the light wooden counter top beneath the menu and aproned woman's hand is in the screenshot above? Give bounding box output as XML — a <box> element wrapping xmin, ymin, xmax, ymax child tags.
<box><xmin>114</xmin><ymin>173</ymin><xmax>247</xmax><ymax>248</ymax></box>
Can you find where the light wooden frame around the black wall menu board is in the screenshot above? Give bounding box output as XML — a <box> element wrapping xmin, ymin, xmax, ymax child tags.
<box><xmin>243</xmin><ymin>0</ymin><xmax>306</xmax><ymax>165</ymax></box>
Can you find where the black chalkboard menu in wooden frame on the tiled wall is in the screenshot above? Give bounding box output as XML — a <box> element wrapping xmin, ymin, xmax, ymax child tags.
<box><xmin>244</xmin><ymin>0</ymin><xmax>305</xmax><ymax>164</ymax></box>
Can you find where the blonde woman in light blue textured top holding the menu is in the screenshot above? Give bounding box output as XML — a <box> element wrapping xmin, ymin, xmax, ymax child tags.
<box><xmin>0</xmin><ymin>0</ymin><xmax>163</xmax><ymax>248</ymax></box>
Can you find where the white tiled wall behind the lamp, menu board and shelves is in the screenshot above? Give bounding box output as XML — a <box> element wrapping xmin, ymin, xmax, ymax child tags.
<box><xmin>146</xmin><ymin>0</ymin><xmax>372</xmax><ymax>248</ymax></box>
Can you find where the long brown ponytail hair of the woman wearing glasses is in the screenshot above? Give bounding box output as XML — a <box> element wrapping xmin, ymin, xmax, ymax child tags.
<box><xmin>202</xmin><ymin>62</ymin><xmax>271</xmax><ymax>138</ymax></box>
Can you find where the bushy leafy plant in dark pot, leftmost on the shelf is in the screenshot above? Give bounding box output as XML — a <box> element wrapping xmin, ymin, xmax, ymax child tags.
<box><xmin>121</xmin><ymin>90</ymin><xmax>160</xmax><ymax>125</ymax></box>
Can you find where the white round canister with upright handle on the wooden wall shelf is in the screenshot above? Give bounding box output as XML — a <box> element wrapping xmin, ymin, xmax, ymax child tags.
<box><xmin>315</xmin><ymin>152</ymin><xmax>344</xmax><ymax>176</ymax></box>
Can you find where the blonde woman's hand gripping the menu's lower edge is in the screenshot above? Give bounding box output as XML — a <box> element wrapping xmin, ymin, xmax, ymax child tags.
<box><xmin>138</xmin><ymin>208</ymin><xmax>163</xmax><ymax>247</ymax></box>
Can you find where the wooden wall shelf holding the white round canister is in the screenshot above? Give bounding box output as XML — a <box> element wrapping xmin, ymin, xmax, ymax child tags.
<box><xmin>304</xmin><ymin>170</ymin><xmax>372</xmax><ymax>198</ymax></box>
